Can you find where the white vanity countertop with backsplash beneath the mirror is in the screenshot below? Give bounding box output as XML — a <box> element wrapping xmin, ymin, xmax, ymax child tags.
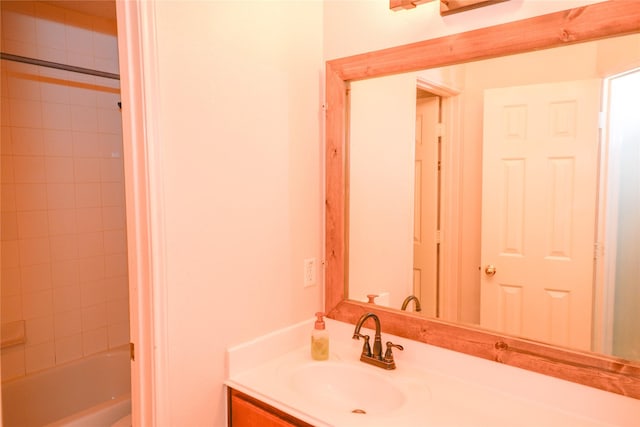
<box><xmin>225</xmin><ymin>319</ymin><xmax>640</xmax><ymax>427</ymax></box>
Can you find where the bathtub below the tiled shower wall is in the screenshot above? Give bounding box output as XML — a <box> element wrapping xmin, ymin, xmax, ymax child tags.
<box><xmin>2</xmin><ymin>347</ymin><xmax>131</xmax><ymax>427</ymax></box>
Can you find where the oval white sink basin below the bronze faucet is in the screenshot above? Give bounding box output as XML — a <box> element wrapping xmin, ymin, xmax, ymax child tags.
<box><xmin>289</xmin><ymin>361</ymin><xmax>406</xmax><ymax>414</ymax></box>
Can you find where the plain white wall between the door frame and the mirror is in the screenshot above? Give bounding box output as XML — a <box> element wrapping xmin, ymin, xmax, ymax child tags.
<box><xmin>139</xmin><ymin>1</ymin><xmax>323</xmax><ymax>426</ymax></box>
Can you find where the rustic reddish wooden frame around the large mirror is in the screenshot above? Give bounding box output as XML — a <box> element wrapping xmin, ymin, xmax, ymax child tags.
<box><xmin>325</xmin><ymin>0</ymin><xmax>640</xmax><ymax>399</ymax></box>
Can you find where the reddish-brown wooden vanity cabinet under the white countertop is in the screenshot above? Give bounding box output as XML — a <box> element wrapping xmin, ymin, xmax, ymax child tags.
<box><xmin>227</xmin><ymin>388</ymin><xmax>313</xmax><ymax>427</ymax></box>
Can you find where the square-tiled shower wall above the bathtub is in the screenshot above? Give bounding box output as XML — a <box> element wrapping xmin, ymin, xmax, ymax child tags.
<box><xmin>0</xmin><ymin>0</ymin><xmax>129</xmax><ymax>380</ymax></box>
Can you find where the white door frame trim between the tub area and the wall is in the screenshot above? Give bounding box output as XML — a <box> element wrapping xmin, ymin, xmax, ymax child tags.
<box><xmin>116</xmin><ymin>1</ymin><xmax>170</xmax><ymax>426</ymax></box>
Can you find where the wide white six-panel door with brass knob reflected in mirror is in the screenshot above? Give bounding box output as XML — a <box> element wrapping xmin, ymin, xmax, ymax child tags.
<box><xmin>480</xmin><ymin>80</ymin><xmax>601</xmax><ymax>350</ymax></box>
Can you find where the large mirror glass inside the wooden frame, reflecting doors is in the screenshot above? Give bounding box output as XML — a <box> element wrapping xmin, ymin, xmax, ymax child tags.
<box><xmin>345</xmin><ymin>34</ymin><xmax>640</xmax><ymax>360</ymax></box>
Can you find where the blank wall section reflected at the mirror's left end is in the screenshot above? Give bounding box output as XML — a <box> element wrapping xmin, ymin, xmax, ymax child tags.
<box><xmin>348</xmin><ymin>73</ymin><xmax>416</xmax><ymax>308</ymax></box>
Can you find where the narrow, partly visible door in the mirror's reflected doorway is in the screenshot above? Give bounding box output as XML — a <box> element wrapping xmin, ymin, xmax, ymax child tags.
<box><xmin>413</xmin><ymin>96</ymin><xmax>440</xmax><ymax>317</ymax></box>
